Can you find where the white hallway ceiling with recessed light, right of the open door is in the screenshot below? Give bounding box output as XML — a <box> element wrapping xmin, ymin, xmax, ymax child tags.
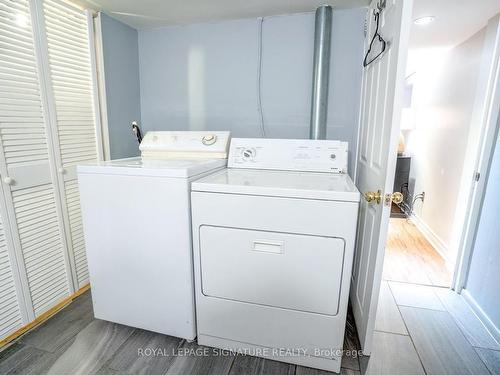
<box><xmin>410</xmin><ymin>0</ymin><xmax>500</xmax><ymax>49</ymax></box>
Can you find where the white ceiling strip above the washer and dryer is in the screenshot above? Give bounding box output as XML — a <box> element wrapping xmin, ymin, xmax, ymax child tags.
<box><xmin>74</xmin><ymin>0</ymin><xmax>369</xmax><ymax>29</ymax></box>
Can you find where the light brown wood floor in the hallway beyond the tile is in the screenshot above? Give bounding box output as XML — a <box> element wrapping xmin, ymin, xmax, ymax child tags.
<box><xmin>383</xmin><ymin>218</ymin><xmax>452</xmax><ymax>287</ymax></box>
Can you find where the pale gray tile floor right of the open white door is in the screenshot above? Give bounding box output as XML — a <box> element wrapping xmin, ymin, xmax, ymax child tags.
<box><xmin>372</xmin><ymin>280</ymin><xmax>500</xmax><ymax>375</ymax></box>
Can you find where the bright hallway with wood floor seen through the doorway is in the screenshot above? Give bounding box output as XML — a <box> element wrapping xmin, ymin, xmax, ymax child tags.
<box><xmin>383</xmin><ymin>24</ymin><xmax>486</xmax><ymax>288</ymax></box>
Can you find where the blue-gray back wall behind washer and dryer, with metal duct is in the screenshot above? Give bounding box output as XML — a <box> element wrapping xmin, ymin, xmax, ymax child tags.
<box><xmin>139</xmin><ymin>9</ymin><xmax>366</xmax><ymax>175</ymax></box>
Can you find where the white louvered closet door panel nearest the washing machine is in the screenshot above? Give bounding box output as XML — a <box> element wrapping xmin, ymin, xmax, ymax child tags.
<box><xmin>43</xmin><ymin>0</ymin><xmax>99</xmax><ymax>287</ymax></box>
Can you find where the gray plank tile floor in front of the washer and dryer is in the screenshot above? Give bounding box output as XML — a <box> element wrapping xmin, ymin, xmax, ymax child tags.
<box><xmin>0</xmin><ymin>292</ymin><xmax>360</xmax><ymax>375</ymax></box>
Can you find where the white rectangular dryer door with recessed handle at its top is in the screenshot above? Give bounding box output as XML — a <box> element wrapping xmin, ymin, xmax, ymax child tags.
<box><xmin>200</xmin><ymin>226</ymin><xmax>344</xmax><ymax>315</ymax></box>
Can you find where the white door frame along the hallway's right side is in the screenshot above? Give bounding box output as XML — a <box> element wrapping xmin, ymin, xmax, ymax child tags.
<box><xmin>451</xmin><ymin>14</ymin><xmax>500</xmax><ymax>293</ymax></box>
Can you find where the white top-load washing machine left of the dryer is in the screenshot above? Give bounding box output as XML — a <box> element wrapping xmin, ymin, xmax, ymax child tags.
<box><xmin>77</xmin><ymin>132</ymin><xmax>229</xmax><ymax>340</ymax></box>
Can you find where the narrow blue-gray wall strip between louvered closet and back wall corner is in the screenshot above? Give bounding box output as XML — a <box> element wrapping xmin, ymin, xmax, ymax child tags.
<box><xmin>101</xmin><ymin>13</ymin><xmax>141</xmax><ymax>159</ymax></box>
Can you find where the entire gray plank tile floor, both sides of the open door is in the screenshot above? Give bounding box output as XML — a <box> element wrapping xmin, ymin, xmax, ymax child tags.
<box><xmin>0</xmin><ymin>281</ymin><xmax>500</xmax><ymax>375</ymax></box>
